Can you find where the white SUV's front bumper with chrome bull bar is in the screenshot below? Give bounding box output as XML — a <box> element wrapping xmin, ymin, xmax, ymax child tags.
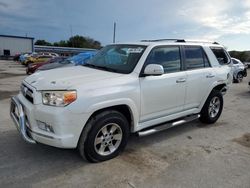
<box><xmin>10</xmin><ymin>94</ymin><xmax>89</xmax><ymax>148</ymax></box>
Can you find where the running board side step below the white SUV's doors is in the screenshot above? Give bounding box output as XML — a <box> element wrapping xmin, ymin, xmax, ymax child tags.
<box><xmin>138</xmin><ymin>114</ymin><xmax>200</xmax><ymax>136</ymax></box>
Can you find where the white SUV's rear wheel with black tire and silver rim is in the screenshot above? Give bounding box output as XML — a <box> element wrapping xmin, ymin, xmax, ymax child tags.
<box><xmin>200</xmin><ymin>90</ymin><xmax>223</xmax><ymax>124</ymax></box>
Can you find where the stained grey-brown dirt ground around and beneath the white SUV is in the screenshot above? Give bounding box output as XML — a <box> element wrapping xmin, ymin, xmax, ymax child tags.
<box><xmin>0</xmin><ymin>61</ymin><xmax>250</xmax><ymax>188</ymax></box>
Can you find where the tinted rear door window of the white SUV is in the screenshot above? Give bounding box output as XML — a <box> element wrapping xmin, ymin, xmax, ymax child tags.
<box><xmin>184</xmin><ymin>46</ymin><xmax>210</xmax><ymax>70</ymax></box>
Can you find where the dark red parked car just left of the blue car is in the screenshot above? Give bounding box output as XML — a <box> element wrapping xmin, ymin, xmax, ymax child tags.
<box><xmin>26</xmin><ymin>56</ymin><xmax>66</xmax><ymax>74</ymax></box>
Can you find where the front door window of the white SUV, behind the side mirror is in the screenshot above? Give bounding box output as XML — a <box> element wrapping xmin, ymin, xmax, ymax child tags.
<box><xmin>146</xmin><ymin>46</ymin><xmax>181</xmax><ymax>73</ymax></box>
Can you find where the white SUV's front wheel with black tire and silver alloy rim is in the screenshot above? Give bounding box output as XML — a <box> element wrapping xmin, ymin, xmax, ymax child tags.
<box><xmin>78</xmin><ymin>110</ymin><xmax>129</xmax><ymax>162</ymax></box>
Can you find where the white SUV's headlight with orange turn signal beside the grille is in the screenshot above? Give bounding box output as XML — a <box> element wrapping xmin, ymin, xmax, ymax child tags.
<box><xmin>42</xmin><ymin>91</ymin><xmax>76</xmax><ymax>106</ymax></box>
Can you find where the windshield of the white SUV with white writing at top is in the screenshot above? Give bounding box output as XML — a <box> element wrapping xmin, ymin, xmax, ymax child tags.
<box><xmin>84</xmin><ymin>44</ymin><xmax>146</xmax><ymax>74</ymax></box>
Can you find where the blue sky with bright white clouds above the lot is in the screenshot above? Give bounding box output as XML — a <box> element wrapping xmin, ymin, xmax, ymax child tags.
<box><xmin>0</xmin><ymin>0</ymin><xmax>250</xmax><ymax>51</ymax></box>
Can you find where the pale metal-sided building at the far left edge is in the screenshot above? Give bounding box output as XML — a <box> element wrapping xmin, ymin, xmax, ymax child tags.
<box><xmin>0</xmin><ymin>35</ymin><xmax>34</xmax><ymax>58</ymax></box>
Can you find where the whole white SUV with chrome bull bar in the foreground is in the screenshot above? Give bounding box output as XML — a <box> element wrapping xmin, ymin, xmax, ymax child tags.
<box><xmin>10</xmin><ymin>40</ymin><xmax>231</xmax><ymax>162</ymax></box>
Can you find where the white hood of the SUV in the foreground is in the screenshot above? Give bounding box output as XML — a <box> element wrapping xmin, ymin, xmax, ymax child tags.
<box><xmin>24</xmin><ymin>66</ymin><xmax>122</xmax><ymax>90</ymax></box>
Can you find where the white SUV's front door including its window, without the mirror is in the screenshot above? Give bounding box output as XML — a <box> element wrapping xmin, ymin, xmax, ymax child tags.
<box><xmin>140</xmin><ymin>46</ymin><xmax>187</xmax><ymax>122</ymax></box>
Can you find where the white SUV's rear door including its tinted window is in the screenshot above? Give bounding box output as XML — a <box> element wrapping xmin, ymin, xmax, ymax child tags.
<box><xmin>183</xmin><ymin>46</ymin><xmax>215</xmax><ymax>110</ymax></box>
